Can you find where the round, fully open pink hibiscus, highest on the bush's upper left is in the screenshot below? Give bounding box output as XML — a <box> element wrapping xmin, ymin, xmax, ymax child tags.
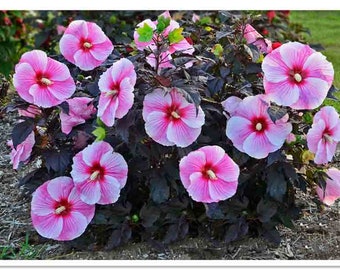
<box><xmin>59</xmin><ymin>20</ymin><xmax>113</xmax><ymax>70</ymax></box>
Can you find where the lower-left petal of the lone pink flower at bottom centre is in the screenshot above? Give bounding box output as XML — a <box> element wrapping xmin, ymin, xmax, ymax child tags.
<box><xmin>187</xmin><ymin>172</ymin><xmax>214</xmax><ymax>203</ymax></box>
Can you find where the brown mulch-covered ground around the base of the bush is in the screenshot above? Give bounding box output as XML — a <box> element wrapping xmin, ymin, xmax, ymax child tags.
<box><xmin>0</xmin><ymin>106</ymin><xmax>340</xmax><ymax>260</ymax></box>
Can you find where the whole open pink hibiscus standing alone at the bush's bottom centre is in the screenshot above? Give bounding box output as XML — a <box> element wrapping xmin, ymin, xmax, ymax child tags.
<box><xmin>179</xmin><ymin>145</ymin><xmax>240</xmax><ymax>203</ymax></box>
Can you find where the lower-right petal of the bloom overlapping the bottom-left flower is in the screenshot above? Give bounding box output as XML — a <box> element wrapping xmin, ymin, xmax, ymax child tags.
<box><xmin>98</xmin><ymin>176</ymin><xmax>121</xmax><ymax>204</ymax></box>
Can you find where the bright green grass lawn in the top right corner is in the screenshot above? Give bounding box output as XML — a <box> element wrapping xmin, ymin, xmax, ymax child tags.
<box><xmin>290</xmin><ymin>10</ymin><xmax>340</xmax><ymax>109</ymax></box>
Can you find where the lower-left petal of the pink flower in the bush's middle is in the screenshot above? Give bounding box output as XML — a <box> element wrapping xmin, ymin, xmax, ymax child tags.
<box><xmin>144</xmin><ymin>111</ymin><xmax>174</xmax><ymax>146</ymax></box>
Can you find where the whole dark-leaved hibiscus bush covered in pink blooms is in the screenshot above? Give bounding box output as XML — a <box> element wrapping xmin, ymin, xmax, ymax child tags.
<box><xmin>7</xmin><ymin>11</ymin><xmax>340</xmax><ymax>249</ymax></box>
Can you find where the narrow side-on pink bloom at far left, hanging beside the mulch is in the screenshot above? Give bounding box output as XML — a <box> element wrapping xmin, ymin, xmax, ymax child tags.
<box><xmin>7</xmin><ymin>131</ymin><xmax>35</xmax><ymax>170</ymax></box>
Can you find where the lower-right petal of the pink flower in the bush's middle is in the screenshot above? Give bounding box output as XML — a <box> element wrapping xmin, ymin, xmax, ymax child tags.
<box><xmin>167</xmin><ymin>119</ymin><xmax>201</xmax><ymax>147</ymax></box>
